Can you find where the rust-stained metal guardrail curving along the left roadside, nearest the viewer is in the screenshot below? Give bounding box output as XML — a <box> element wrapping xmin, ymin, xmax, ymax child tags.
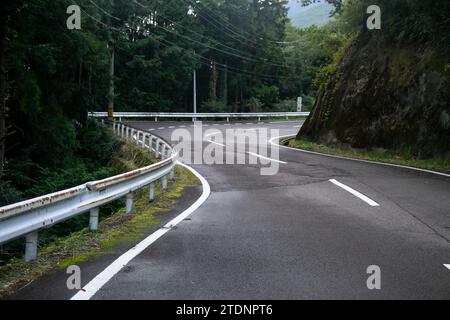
<box><xmin>0</xmin><ymin>123</ymin><xmax>177</xmax><ymax>261</ymax></box>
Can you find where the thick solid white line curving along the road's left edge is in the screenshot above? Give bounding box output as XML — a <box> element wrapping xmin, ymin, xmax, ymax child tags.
<box><xmin>70</xmin><ymin>162</ymin><xmax>211</xmax><ymax>300</ymax></box>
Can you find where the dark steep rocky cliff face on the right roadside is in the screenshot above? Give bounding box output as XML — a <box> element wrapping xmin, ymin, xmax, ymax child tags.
<box><xmin>298</xmin><ymin>32</ymin><xmax>450</xmax><ymax>158</ymax></box>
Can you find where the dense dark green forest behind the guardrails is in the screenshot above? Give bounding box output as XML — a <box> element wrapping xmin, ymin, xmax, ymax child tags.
<box><xmin>0</xmin><ymin>0</ymin><xmax>344</xmax><ymax>205</ymax></box>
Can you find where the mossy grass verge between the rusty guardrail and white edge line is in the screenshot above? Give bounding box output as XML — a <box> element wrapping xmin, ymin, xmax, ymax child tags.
<box><xmin>0</xmin><ymin>163</ymin><xmax>199</xmax><ymax>298</ymax></box>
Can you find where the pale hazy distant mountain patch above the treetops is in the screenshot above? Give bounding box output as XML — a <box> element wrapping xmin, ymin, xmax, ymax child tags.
<box><xmin>288</xmin><ymin>0</ymin><xmax>333</xmax><ymax>28</ymax></box>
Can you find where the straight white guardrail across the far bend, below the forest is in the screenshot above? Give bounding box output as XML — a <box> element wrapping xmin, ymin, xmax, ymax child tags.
<box><xmin>88</xmin><ymin>112</ymin><xmax>310</xmax><ymax>122</ymax></box>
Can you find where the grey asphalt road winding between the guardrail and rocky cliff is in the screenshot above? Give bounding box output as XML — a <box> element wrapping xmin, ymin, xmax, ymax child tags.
<box><xmin>11</xmin><ymin>122</ymin><xmax>450</xmax><ymax>300</ymax></box>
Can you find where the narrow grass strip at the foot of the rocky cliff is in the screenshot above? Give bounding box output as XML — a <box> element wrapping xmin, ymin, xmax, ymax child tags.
<box><xmin>281</xmin><ymin>138</ymin><xmax>450</xmax><ymax>172</ymax></box>
